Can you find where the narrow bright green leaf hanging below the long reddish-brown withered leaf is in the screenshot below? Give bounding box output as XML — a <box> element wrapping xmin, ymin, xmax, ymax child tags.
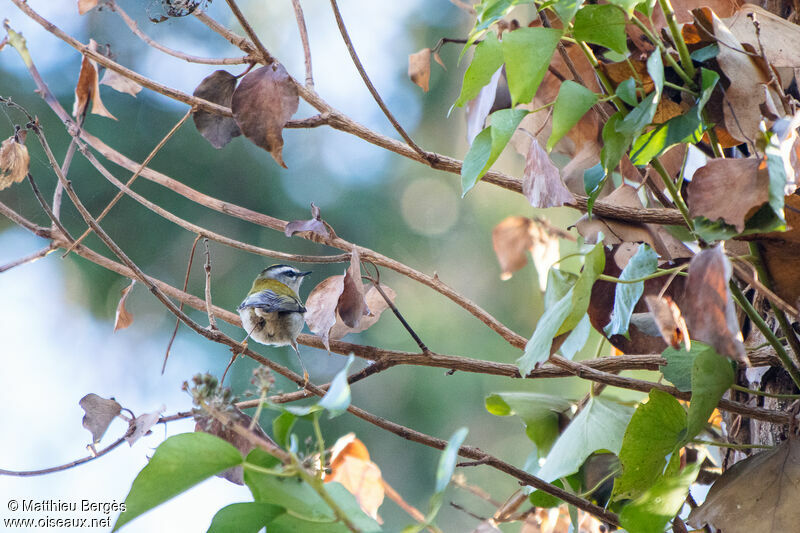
<box><xmin>685</xmin><ymin>348</ymin><xmax>735</xmax><ymax>442</ymax></box>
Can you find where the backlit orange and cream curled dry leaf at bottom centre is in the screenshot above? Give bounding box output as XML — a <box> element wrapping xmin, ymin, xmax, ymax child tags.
<box><xmin>325</xmin><ymin>433</ymin><xmax>384</xmax><ymax>521</ymax></box>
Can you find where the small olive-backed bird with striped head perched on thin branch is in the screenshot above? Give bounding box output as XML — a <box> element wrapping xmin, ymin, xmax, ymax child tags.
<box><xmin>237</xmin><ymin>265</ymin><xmax>311</xmax><ymax>382</ymax></box>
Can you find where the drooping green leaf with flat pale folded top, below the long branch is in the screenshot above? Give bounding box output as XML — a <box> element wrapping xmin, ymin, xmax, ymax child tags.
<box><xmin>486</xmin><ymin>392</ymin><xmax>572</xmax><ymax>455</ymax></box>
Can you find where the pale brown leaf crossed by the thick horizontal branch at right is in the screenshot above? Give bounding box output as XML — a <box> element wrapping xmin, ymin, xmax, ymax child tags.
<box><xmin>575</xmin><ymin>184</ymin><xmax>692</xmax><ymax>259</ymax></box>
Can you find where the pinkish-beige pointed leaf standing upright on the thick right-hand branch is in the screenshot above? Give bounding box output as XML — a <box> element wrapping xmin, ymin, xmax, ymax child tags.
<box><xmin>522</xmin><ymin>139</ymin><xmax>575</xmax><ymax>207</ymax></box>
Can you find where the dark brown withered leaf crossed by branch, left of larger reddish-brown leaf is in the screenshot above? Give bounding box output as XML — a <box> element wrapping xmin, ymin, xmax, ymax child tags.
<box><xmin>192</xmin><ymin>70</ymin><xmax>242</xmax><ymax>148</ymax></box>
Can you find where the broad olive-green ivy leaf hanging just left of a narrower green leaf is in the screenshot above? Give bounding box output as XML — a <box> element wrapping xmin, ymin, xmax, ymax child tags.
<box><xmin>612</xmin><ymin>389</ymin><xmax>686</xmax><ymax>500</ymax></box>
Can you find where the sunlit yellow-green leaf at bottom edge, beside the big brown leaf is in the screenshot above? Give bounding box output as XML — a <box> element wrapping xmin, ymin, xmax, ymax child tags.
<box><xmin>619</xmin><ymin>463</ymin><xmax>700</xmax><ymax>533</ymax></box>
